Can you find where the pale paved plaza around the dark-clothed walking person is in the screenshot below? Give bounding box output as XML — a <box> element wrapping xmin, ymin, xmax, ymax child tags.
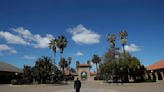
<box><xmin>0</xmin><ymin>81</ymin><xmax>164</xmax><ymax>92</ymax></box>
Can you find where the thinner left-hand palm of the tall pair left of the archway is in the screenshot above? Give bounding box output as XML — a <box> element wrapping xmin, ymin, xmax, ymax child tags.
<box><xmin>49</xmin><ymin>38</ymin><xmax>58</xmax><ymax>64</ymax></box>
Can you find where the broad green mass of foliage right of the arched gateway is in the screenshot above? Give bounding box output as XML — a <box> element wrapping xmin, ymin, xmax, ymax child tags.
<box><xmin>100</xmin><ymin>52</ymin><xmax>145</xmax><ymax>82</ymax></box>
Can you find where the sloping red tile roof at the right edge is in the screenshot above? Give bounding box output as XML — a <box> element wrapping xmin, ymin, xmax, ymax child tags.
<box><xmin>146</xmin><ymin>60</ymin><xmax>164</xmax><ymax>70</ymax></box>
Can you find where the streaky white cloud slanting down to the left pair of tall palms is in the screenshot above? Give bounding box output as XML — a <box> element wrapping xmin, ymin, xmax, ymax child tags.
<box><xmin>11</xmin><ymin>27</ymin><xmax>54</xmax><ymax>48</ymax></box>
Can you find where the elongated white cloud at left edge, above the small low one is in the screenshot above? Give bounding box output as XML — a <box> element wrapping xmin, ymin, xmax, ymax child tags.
<box><xmin>0</xmin><ymin>31</ymin><xmax>28</xmax><ymax>45</ymax></box>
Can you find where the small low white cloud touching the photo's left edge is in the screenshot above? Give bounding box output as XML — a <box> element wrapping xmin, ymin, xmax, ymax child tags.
<box><xmin>0</xmin><ymin>44</ymin><xmax>17</xmax><ymax>56</ymax></box>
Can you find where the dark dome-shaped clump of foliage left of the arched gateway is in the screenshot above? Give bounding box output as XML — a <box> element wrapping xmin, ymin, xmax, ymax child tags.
<box><xmin>23</xmin><ymin>56</ymin><xmax>63</xmax><ymax>83</ymax></box>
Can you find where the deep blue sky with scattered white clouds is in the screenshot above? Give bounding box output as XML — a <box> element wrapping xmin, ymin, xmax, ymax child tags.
<box><xmin>0</xmin><ymin>0</ymin><xmax>164</xmax><ymax>71</ymax></box>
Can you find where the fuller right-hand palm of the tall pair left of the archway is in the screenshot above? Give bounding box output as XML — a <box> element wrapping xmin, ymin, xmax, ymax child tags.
<box><xmin>57</xmin><ymin>35</ymin><xmax>68</xmax><ymax>64</ymax></box>
